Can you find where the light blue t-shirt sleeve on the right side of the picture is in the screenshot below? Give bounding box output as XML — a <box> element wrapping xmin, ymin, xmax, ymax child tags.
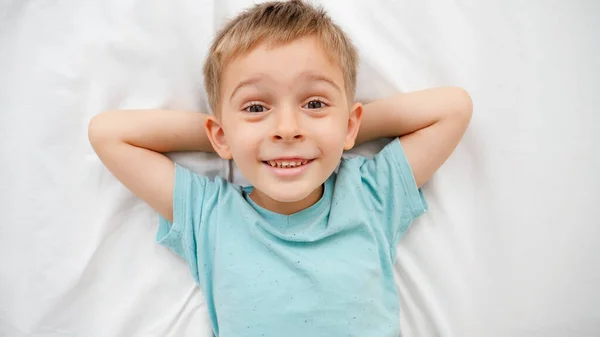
<box><xmin>360</xmin><ymin>138</ymin><xmax>427</xmax><ymax>251</ymax></box>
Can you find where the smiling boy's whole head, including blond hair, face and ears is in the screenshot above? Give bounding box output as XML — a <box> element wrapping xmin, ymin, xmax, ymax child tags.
<box><xmin>204</xmin><ymin>0</ymin><xmax>362</xmax><ymax>209</ymax></box>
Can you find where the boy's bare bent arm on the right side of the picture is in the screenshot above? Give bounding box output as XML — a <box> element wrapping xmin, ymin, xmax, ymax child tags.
<box><xmin>357</xmin><ymin>87</ymin><xmax>473</xmax><ymax>187</ymax></box>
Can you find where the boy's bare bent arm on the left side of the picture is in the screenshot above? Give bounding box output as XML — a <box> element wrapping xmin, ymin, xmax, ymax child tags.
<box><xmin>88</xmin><ymin>110</ymin><xmax>212</xmax><ymax>221</ymax></box>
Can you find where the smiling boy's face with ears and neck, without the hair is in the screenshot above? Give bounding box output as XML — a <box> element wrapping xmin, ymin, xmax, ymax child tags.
<box><xmin>207</xmin><ymin>37</ymin><xmax>362</xmax><ymax>213</ymax></box>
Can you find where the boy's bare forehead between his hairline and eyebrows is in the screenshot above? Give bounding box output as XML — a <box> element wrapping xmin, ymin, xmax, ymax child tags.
<box><xmin>221</xmin><ymin>37</ymin><xmax>344</xmax><ymax>95</ymax></box>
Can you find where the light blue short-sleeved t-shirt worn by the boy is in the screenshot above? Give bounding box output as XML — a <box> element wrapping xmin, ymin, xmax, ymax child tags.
<box><xmin>157</xmin><ymin>140</ymin><xmax>427</xmax><ymax>337</ymax></box>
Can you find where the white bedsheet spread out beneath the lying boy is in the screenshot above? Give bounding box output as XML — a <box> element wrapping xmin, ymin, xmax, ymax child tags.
<box><xmin>0</xmin><ymin>0</ymin><xmax>600</xmax><ymax>337</ymax></box>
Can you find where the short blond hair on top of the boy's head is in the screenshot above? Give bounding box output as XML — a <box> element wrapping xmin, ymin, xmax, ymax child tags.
<box><xmin>203</xmin><ymin>0</ymin><xmax>358</xmax><ymax>115</ymax></box>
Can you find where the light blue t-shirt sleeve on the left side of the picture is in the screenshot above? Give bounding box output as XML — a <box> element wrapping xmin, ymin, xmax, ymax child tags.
<box><xmin>156</xmin><ymin>164</ymin><xmax>214</xmax><ymax>285</ymax></box>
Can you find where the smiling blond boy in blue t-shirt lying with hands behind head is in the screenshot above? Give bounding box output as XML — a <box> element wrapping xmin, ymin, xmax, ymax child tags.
<box><xmin>89</xmin><ymin>0</ymin><xmax>472</xmax><ymax>337</ymax></box>
